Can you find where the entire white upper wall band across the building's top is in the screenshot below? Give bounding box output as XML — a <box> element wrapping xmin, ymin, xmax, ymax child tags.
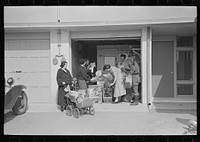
<box><xmin>4</xmin><ymin>6</ymin><xmax>197</xmax><ymax>24</ymax></box>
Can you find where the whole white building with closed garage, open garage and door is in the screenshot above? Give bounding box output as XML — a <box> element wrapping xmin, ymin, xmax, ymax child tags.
<box><xmin>4</xmin><ymin>6</ymin><xmax>197</xmax><ymax>109</ymax></box>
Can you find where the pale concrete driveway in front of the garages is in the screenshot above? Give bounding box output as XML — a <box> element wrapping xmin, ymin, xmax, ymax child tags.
<box><xmin>4</xmin><ymin>107</ymin><xmax>197</xmax><ymax>135</ymax></box>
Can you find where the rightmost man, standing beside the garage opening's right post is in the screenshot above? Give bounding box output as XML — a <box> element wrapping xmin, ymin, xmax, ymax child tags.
<box><xmin>125</xmin><ymin>51</ymin><xmax>140</xmax><ymax>105</ymax></box>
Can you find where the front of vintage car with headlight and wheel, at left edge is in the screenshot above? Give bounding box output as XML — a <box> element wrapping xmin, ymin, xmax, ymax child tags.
<box><xmin>4</xmin><ymin>77</ymin><xmax>28</xmax><ymax>115</ymax></box>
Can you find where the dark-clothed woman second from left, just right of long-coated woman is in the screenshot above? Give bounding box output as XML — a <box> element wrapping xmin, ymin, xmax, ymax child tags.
<box><xmin>78</xmin><ymin>59</ymin><xmax>90</xmax><ymax>90</ymax></box>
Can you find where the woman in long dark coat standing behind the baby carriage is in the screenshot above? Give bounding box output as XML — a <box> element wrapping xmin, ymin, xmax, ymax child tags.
<box><xmin>57</xmin><ymin>61</ymin><xmax>72</xmax><ymax>111</ymax></box>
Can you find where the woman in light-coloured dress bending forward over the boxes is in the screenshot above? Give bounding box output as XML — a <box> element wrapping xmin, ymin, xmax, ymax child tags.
<box><xmin>104</xmin><ymin>65</ymin><xmax>126</xmax><ymax>103</ymax></box>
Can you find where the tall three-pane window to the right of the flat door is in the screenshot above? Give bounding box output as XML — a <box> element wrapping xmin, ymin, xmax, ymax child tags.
<box><xmin>176</xmin><ymin>36</ymin><xmax>194</xmax><ymax>96</ymax></box>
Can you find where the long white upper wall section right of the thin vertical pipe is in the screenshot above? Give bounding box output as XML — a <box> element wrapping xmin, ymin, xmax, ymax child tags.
<box><xmin>60</xmin><ymin>6</ymin><xmax>197</xmax><ymax>22</ymax></box>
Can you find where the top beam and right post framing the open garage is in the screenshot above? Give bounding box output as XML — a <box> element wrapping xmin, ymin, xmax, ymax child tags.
<box><xmin>70</xmin><ymin>27</ymin><xmax>152</xmax><ymax>106</ymax></box>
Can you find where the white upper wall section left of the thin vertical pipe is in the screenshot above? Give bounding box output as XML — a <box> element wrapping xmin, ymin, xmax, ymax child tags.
<box><xmin>4</xmin><ymin>6</ymin><xmax>57</xmax><ymax>23</ymax></box>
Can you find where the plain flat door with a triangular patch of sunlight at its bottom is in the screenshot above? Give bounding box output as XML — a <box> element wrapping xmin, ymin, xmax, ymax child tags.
<box><xmin>152</xmin><ymin>41</ymin><xmax>174</xmax><ymax>97</ymax></box>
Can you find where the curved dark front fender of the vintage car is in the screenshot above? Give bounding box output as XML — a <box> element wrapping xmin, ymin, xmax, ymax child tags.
<box><xmin>4</xmin><ymin>85</ymin><xmax>26</xmax><ymax>111</ymax></box>
